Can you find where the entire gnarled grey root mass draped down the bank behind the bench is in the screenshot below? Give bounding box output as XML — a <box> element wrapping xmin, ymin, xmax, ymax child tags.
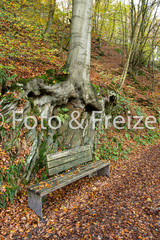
<box><xmin>0</xmin><ymin>78</ymin><xmax>115</xmax><ymax>181</ymax></box>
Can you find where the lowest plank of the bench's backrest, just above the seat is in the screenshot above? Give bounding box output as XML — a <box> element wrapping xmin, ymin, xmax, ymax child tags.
<box><xmin>48</xmin><ymin>156</ymin><xmax>92</xmax><ymax>176</ymax></box>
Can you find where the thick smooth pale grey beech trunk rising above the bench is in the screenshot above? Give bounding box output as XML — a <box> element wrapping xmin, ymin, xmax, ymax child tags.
<box><xmin>67</xmin><ymin>0</ymin><xmax>101</xmax><ymax>109</ymax></box>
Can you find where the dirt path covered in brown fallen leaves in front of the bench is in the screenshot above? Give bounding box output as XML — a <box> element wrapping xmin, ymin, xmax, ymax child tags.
<box><xmin>0</xmin><ymin>145</ymin><xmax>160</xmax><ymax>240</ymax></box>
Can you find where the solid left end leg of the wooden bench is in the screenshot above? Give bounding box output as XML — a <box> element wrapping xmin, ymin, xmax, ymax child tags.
<box><xmin>28</xmin><ymin>190</ymin><xmax>43</xmax><ymax>219</ymax></box>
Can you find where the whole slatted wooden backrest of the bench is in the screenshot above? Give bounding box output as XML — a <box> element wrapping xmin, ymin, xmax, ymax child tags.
<box><xmin>47</xmin><ymin>145</ymin><xmax>92</xmax><ymax>176</ymax></box>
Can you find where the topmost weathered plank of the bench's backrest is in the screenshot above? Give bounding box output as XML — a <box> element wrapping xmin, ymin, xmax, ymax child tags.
<box><xmin>47</xmin><ymin>145</ymin><xmax>91</xmax><ymax>161</ymax></box>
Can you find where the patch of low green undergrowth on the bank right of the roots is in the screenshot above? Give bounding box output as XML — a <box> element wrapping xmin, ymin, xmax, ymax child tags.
<box><xmin>95</xmin><ymin>93</ymin><xmax>160</xmax><ymax>161</ymax></box>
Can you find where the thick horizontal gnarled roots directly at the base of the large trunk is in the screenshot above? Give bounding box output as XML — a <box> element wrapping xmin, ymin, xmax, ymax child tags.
<box><xmin>24</xmin><ymin>78</ymin><xmax>101</xmax><ymax>110</ymax></box>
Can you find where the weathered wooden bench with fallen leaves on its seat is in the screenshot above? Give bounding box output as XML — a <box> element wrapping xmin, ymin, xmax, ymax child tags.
<box><xmin>28</xmin><ymin>145</ymin><xmax>110</xmax><ymax>218</ymax></box>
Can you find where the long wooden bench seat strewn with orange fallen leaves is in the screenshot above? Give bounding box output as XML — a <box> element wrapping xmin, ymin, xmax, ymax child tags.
<box><xmin>28</xmin><ymin>160</ymin><xmax>109</xmax><ymax>197</ymax></box>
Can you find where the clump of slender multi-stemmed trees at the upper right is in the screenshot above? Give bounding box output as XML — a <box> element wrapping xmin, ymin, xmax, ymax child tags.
<box><xmin>130</xmin><ymin>0</ymin><xmax>159</xmax><ymax>70</ymax></box>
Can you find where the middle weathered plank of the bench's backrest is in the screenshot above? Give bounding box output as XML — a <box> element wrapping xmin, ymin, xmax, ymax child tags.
<box><xmin>47</xmin><ymin>151</ymin><xmax>92</xmax><ymax>169</ymax></box>
